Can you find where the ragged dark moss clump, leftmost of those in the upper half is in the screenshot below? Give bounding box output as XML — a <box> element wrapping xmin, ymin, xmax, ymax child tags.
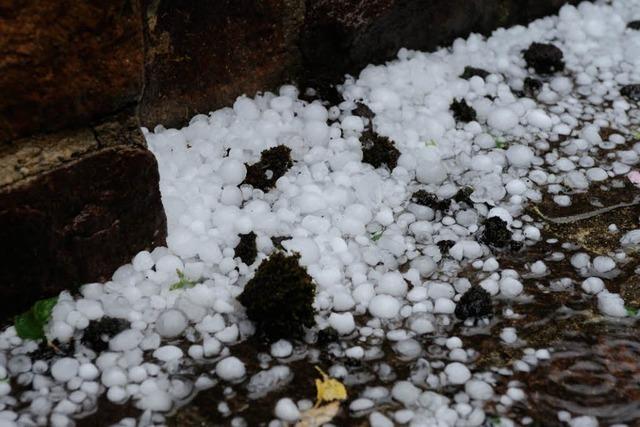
<box><xmin>243</xmin><ymin>145</ymin><xmax>293</xmax><ymax>192</ymax></box>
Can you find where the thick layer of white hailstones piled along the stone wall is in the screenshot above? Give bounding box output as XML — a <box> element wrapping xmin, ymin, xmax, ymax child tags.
<box><xmin>0</xmin><ymin>0</ymin><xmax>640</xmax><ymax>427</ymax></box>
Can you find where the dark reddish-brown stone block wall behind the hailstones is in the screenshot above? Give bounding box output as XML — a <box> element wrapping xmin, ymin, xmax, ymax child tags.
<box><xmin>0</xmin><ymin>0</ymin><xmax>576</xmax><ymax>315</ymax></box>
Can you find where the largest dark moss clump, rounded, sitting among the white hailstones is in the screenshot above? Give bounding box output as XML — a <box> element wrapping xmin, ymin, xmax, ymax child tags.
<box><xmin>238</xmin><ymin>252</ymin><xmax>316</xmax><ymax>341</ymax></box>
